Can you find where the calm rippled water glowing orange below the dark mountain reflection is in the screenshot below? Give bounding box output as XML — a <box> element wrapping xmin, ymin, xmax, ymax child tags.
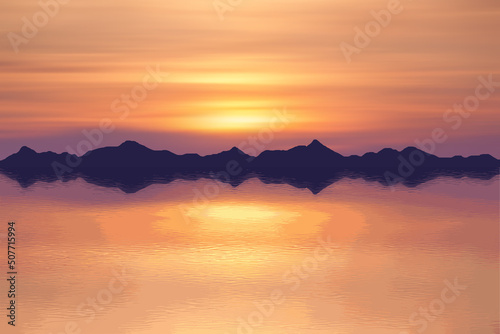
<box><xmin>0</xmin><ymin>176</ymin><xmax>500</xmax><ymax>334</ymax></box>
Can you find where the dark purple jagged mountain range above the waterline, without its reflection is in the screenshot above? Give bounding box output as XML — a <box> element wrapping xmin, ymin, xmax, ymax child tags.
<box><xmin>0</xmin><ymin>140</ymin><xmax>500</xmax><ymax>171</ymax></box>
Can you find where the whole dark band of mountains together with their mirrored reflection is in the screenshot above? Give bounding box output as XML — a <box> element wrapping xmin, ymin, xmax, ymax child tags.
<box><xmin>0</xmin><ymin>140</ymin><xmax>500</xmax><ymax>194</ymax></box>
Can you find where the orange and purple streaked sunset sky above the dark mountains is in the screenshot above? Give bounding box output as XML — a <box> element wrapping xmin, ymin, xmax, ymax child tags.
<box><xmin>0</xmin><ymin>0</ymin><xmax>500</xmax><ymax>159</ymax></box>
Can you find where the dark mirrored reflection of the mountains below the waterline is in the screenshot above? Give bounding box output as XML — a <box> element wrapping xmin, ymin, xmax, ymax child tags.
<box><xmin>0</xmin><ymin>169</ymin><xmax>498</xmax><ymax>194</ymax></box>
